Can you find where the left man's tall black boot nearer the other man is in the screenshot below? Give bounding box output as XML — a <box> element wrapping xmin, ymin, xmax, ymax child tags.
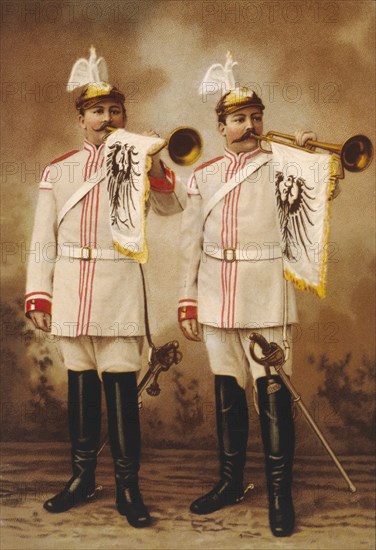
<box><xmin>103</xmin><ymin>372</ymin><xmax>151</xmax><ymax>527</ymax></box>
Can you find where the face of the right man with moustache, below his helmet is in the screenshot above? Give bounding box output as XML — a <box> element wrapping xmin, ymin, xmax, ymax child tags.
<box><xmin>218</xmin><ymin>107</ymin><xmax>263</xmax><ymax>153</ymax></box>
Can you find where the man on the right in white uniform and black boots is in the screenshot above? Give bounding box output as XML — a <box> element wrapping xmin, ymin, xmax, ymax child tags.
<box><xmin>179</xmin><ymin>77</ymin><xmax>324</xmax><ymax>537</ymax></box>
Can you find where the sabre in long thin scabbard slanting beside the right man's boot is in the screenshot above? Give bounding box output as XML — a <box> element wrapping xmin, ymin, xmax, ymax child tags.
<box><xmin>249</xmin><ymin>332</ymin><xmax>356</xmax><ymax>493</ymax></box>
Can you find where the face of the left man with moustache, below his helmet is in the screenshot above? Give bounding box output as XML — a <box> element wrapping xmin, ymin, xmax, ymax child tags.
<box><xmin>78</xmin><ymin>99</ymin><xmax>125</xmax><ymax>145</ymax></box>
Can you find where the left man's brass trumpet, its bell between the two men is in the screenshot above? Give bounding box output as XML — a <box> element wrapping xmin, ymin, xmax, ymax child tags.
<box><xmin>103</xmin><ymin>126</ymin><xmax>203</xmax><ymax>166</ymax></box>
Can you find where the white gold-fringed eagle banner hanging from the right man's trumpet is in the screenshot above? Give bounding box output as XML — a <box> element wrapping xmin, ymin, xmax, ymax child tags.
<box><xmin>271</xmin><ymin>143</ymin><xmax>338</xmax><ymax>298</ymax></box>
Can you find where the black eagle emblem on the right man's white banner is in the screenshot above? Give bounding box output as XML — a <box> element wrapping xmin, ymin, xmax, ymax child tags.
<box><xmin>275</xmin><ymin>172</ymin><xmax>316</xmax><ymax>261</ymax></box>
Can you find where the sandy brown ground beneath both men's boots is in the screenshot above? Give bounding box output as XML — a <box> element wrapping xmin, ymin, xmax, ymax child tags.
<box><xmin>1</xmin><ymin>443</ymin><xmax>375</xmax><ymax>550</ymax></box>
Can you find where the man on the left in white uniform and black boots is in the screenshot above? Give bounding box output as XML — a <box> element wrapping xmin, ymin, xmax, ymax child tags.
<box><xmin>26</xmin><ymin>75</ymin><xmax>182</xmax><ymax>527</ymax></box>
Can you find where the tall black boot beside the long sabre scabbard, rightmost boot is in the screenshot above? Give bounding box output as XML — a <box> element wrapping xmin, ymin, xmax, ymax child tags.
<box><xmin>257</xmin><ymin>376</ymin><xmax>295</xmax><ymax>537</ymax></box>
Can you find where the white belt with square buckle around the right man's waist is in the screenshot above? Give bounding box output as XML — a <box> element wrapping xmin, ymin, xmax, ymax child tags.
<box><xmin>203</xmin><ymin>245</ymin><xmax>282</xmax><ymax>262</ymax></box>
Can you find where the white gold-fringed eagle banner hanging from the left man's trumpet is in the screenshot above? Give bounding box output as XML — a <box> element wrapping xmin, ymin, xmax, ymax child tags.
<box><xmin>105</xmin><ymin>129</ymin><xmax>164</xmax><ymax>263</ymax></box>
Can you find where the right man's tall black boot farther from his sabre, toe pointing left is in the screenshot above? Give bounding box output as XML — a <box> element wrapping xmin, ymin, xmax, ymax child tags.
<box><xmin>190</xmin><ymin>376</ymin><xmax>248</xmax><ymax>514</ymax></box>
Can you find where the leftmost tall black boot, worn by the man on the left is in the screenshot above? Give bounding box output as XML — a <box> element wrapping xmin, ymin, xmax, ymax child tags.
<box><xmin>43</xmin><ymin>370</ymin><xmax>101</xmax><ymax>513</ymax></box>
